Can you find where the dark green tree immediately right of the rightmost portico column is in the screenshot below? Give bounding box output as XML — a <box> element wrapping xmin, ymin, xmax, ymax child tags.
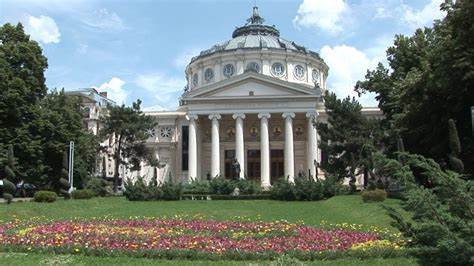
<box><xmin>317</xmin><ymin>93</ymin><xmax>381</xmax><ymax>189</ymax></box>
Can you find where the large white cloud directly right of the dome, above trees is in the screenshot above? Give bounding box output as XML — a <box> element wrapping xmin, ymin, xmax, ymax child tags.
<box><xmin>320</xmin><ymin>45</ymin><xmax>380</xmax><ymax>106</ymax></box>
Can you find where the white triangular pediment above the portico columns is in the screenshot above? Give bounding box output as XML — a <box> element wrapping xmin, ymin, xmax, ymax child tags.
<box><xmin>186</xmin><ymin>73</ymin><xmax>317</xmax><ymax>99</ymax></box>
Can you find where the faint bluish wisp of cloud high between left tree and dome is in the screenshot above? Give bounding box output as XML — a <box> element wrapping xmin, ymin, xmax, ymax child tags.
<box><xmin>82</xmin><ymin>8</ymin><xmax>126</xmax><ymax>31</ymax></box>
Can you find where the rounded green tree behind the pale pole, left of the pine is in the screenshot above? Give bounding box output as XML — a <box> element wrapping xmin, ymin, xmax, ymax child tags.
<box><xmin>39</xmin><ymin>90</ymin><xmax>99</xmax><ymax>187</ymax></box>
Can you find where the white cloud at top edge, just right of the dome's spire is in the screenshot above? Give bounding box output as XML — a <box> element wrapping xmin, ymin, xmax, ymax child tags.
<box><xmin>293</xmin><ymin>0</ymin><xmax>349</xmax><ymax>34</ymax></box>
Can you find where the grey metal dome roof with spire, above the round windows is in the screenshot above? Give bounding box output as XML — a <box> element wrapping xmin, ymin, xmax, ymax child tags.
<box><xmin>191</xmin><ymin>7</ymin><xmax>322</xmax><ymax>62</ymax></box>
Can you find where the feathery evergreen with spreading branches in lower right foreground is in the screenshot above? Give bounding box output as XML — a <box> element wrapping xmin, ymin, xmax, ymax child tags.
<box><xmin>376</xmin><ymin>153</ymin><xmax>474</xmax><ymax>265</ymax></box>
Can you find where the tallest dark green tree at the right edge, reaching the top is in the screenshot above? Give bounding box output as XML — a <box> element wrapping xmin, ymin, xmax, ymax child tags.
<box><xmin>356</xmin><ymin>0</ymin><xmax>474</xmax><ymax>177</ymax></box>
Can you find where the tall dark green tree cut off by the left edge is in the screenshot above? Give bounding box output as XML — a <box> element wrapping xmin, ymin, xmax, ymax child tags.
<box><xmin>0</xmin><ymin>23</ymin><xmax>48</xmax><ymax>181</ymax></box>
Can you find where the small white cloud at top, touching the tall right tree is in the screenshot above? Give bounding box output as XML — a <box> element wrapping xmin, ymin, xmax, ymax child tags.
<box><xmin>402</xmin><ymin>0</ymin><xmax>445</xmax><ymax>29</ymax></box>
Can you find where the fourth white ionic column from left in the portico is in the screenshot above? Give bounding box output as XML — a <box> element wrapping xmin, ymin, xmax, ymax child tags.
<box><xmin>258</xmin><ymin>113</ymin><xmax>270</xmax><ymax>188</ymax></box>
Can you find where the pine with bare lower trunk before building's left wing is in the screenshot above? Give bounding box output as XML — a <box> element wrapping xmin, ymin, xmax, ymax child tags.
<box><xmin>100</xmin><ymin>100</ymin><xmax>157</xmax><ymax>192</ymax></box>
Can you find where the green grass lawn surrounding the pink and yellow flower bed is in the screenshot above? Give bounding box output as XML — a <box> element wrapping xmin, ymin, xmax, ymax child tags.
<box><xmin>0</xmin><ymin>195</ymin><xmax>416</xmax><ymax>265</ymax></box>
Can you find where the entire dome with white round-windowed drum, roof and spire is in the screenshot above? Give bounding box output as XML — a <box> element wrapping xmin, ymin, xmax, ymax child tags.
<box><xmin>185</xmin><ymin>7</ymin><xmax>328</xmax><ymax>91</ymax></box>
